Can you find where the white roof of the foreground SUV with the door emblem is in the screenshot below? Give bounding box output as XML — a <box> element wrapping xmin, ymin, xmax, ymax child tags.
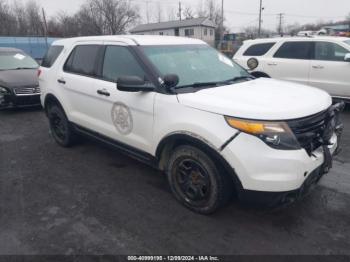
<box><xmin>53</xmin><ymin>35</ymin><xmax>206</xmax><ymax>46</ymax></box>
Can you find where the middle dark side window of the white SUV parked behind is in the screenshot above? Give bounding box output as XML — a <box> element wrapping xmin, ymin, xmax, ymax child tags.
<box><xmin>274</xmin><ymin>42</ymin><xmax>313</xmax><ymax>59</ymax></box>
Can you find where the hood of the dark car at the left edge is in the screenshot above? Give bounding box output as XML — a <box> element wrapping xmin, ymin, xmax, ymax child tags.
<box><xmin>0</xmin><ymin>69</ymin><xmax>38</xmax><ymax>88</ymax></box>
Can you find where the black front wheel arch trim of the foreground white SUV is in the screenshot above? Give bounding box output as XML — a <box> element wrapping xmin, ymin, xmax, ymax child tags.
<box><xmin>156</xmin><ymin>132</ymin><xmax>242</xmax><ymax>191</ymax></box>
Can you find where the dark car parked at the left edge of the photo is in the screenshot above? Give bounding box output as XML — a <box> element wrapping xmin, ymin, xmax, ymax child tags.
<box><xmin>0</xmin><ymin>48</ymin><xmax>40</xmax><ymax>109</ymax></box>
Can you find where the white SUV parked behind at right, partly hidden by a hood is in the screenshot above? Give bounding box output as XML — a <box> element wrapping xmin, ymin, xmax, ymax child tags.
<box><xmin>234</xmin><ymin>36</ymin><xmax>350</xmax><ymax>101</ymax></box>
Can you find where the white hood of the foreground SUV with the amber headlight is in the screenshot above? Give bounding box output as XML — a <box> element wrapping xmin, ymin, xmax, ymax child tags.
<box><xmin>178</xmin><ymin>78</ymin><xmax>332</xmax><ymax>120</ymax></box>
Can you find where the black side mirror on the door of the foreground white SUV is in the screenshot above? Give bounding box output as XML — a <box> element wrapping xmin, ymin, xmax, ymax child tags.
<box><xmin>117</xmin><ymin>76</ymin><xmax>154</xmax><ymax>92</ymax></box>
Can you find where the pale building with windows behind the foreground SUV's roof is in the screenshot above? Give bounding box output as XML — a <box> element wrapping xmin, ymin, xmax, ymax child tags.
<box><xmin>130</xmin><ymin>17</ymin><xmax>216</xmax><ymax>46</ymax></box>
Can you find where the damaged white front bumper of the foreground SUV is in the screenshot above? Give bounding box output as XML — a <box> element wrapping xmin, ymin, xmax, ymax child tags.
<box><xmin>222</xmin><ymin>133</ymin><xmax>338</xmax><ymax>193</ymax></box>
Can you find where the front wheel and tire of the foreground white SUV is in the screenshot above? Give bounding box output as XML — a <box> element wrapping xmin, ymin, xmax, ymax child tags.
<box><xmin>166</xmin><ymin>146</ymin><xmax>233</xmax><ymax>215</ymax></box>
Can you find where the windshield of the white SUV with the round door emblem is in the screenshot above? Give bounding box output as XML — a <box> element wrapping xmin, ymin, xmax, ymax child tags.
<box><xmin>143</xmin><ymin>45</ymin><xmax>250</xmax><ymax>86</ymax></box>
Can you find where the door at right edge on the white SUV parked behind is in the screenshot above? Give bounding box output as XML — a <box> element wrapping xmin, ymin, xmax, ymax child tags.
<box><xmin>309</xmin><ymin>41</ymin><xmax>350</xmax><ymax>97</ymax></box>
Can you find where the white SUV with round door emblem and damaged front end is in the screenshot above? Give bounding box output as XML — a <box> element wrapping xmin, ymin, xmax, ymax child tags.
<box><xmin>39</xmin><ymin>35</ymin><xmax>342</xmax><ymax>214</ymax></box>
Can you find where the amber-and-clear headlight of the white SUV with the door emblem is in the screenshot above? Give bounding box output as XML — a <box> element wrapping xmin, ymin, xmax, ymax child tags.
<box><xmin>225</xmin><ymin>117</ymin><xmax>301</xmax><ymax>150</ymax></box>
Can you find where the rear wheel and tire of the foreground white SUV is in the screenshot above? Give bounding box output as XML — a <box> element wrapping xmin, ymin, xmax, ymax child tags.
<box><xmin>48</xmin><ymin>104</ymin><xmax>76</xmax><ymax>147</ymax></box>
